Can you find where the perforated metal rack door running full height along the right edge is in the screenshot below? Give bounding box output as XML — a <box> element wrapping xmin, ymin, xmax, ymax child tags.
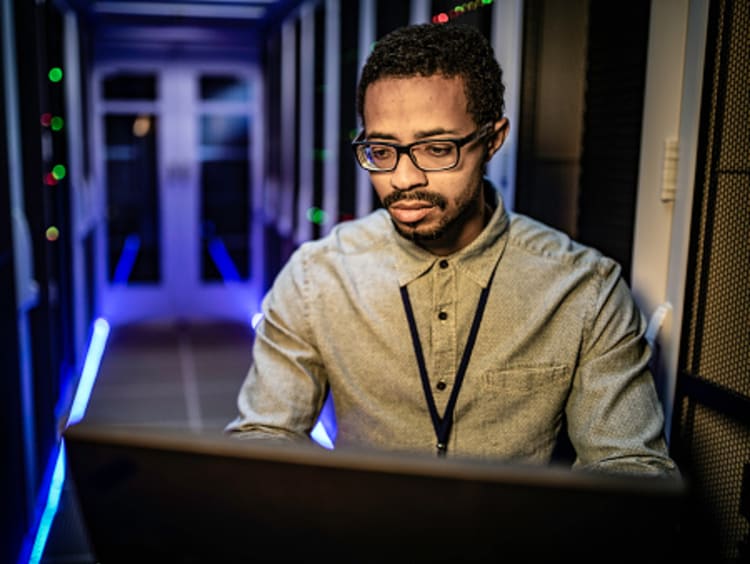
<box><xmin>676</xmin><ymin>0</ymin><xmax>750</xmax><ymax>562</ymax></box>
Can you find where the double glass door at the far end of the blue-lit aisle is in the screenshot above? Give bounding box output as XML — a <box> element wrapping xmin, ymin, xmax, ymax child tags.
<box><xmin>94</xmin><ymin>65</ymin><xmax>262</xmax><ymax>323</ymax></box>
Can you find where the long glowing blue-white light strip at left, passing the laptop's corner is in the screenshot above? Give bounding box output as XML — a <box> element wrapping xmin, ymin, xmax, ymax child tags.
<box><xmin>18</xmin><ymin>318</ymin><xmax>110</xmax><ymax>564</ymax></box>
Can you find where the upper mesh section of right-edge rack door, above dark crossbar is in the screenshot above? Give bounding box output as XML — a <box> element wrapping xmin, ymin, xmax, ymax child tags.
<box><xmin>686</xmin><ymin>2</ymin><xmax>750</xmax><ymax>395</ymax></box>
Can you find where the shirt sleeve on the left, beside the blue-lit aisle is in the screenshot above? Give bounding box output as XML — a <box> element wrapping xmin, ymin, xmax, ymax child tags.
<box><xmin>225</xmin><ymin>248</ymin><xmax>326</xmax><ymax>440</ymax></box>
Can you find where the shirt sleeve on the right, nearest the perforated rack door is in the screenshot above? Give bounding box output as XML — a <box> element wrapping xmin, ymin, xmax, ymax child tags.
<box><xmin>566</xmin><ymin>259</ymin><xmax>679</xmax><ymax>476</ymax></box>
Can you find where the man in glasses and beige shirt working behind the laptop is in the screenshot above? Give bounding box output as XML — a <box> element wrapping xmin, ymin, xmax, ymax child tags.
<box><xmin>227</xmin><ymin>24</ymin><xmax>677</xmax><ymax>475</ymax></box>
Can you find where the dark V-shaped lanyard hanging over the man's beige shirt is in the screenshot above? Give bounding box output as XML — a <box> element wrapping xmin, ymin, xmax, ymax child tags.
<box><xmin>400</xmin><ymin>271</ymin><xmax>495</xmax><ymax>456</ymax></box>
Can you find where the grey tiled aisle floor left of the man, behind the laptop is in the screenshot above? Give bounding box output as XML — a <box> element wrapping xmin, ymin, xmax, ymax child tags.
<box><xmin>41</xmin><ymin>323</ymin><xmax>253</xmax><ymax>564</ymax></box>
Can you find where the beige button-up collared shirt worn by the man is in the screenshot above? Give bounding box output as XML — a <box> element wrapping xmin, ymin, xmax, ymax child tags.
<box><xmin>227</xmin><ymin>186</ymin><xmax>676</xmax><ymax>474</ymax></box>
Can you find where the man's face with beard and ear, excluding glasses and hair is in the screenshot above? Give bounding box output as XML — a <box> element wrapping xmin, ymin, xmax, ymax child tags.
<box><xmin>363</xmin><ymin>76</ymin><xmax>505</xmax><ymax>255</ymax></box>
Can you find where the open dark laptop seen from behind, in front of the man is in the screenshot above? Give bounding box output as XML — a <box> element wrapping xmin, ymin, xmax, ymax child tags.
<box><xmin>64</xmin><ymin>422</ymin><xmax>686</xmax><ymax>564</ymax></box>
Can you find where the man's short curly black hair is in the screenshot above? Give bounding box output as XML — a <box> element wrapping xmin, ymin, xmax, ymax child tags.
<box><xmin>357</xmin><ymin>23</ymin><xmax>505</xmax><ymax>125</ymax></box>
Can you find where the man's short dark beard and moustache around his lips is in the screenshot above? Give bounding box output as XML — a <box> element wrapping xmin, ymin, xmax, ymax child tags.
<box><xmin>382</xmin><ymin>181</ymin><xmax>483</xmax><ymax>243</ymax></box>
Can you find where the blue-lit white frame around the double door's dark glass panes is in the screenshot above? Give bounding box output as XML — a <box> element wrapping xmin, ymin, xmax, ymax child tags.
<box><xmin>91</xmin><ymin>59</ymin><xmax>264</xmax><ymax>325</ymax></box>
